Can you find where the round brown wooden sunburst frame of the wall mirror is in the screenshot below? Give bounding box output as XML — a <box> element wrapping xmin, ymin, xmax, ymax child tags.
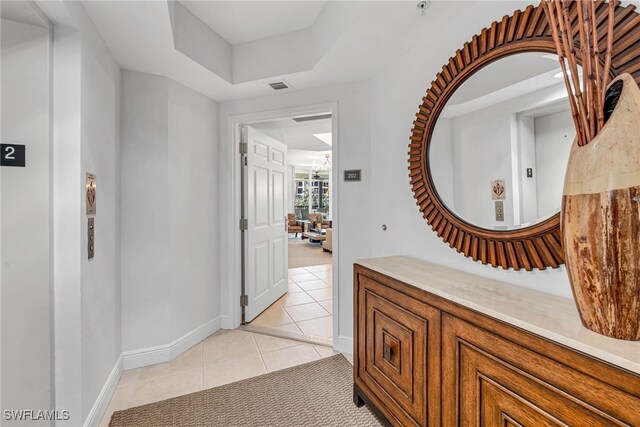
<box><xmin>409</xmin><ymin>1</ymin><xmax>640</xmax><ymax>271</ymax></box>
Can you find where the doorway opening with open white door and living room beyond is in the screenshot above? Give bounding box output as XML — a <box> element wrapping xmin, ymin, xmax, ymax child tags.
<box><xmin>241</xmin><ymin>112</ymin><xmax>337</xmax><ymax>345</ymax></box>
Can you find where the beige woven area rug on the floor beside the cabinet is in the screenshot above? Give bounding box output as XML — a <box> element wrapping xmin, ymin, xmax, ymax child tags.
<box><xmin>109</xmin><ymin>354</ymin><xmax>382</xmax><ymax>427</ymax></box>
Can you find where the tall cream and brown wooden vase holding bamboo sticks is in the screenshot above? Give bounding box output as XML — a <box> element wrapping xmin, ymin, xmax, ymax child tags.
<box><xmin>561</xmin><ymin>74</ymin><xmax>640</xmax><ymax>341</ymax></box>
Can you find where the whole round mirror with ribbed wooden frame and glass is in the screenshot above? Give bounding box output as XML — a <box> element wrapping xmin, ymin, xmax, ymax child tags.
<box><xmin>407</xmin><ymin>2</ymin><xmax>640</xmax><ymax>270</ymax></box>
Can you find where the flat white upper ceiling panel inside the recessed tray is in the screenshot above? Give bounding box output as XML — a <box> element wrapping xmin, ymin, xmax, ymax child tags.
<box><xmin>180</xmin><ymin>0</ymin><xmax>326</xmax><ymax>44</ymax></box>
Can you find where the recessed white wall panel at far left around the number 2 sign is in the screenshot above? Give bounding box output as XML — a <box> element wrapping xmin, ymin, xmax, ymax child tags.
<box><xmin>0</xmin><ymin>19</ymin><xmax>53</xmax><ymax>425</ymax></box>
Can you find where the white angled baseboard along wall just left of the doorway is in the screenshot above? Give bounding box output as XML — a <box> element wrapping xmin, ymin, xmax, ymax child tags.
<box><xmin>122</xmin><ymin>316</ymin><xmax>221</xmax><ymax>370</ymax></box>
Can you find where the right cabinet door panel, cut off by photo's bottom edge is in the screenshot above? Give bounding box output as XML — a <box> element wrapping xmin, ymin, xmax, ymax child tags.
<box><xmin>442</xmin><ymin>315</ymin><xmax>640</xmax><ymax>427</ymax></box>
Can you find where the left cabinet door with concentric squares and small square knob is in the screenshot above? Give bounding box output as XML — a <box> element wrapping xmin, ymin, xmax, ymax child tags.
<box><xmin>356</xmin><ymin>276</ymin><xmax>440</xmax><ymax>426</ymax></box>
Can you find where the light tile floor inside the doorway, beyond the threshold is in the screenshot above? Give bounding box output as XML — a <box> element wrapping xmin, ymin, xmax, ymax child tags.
<box><xmin>249</xmin><ymin>264</ymin><xmax>333</xmax><ymax>344</ymax></box>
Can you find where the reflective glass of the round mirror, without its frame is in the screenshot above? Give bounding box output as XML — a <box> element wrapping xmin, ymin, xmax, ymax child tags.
<box><xmin>428</xmin><ymin>52</ymin><xmax>575</xmax><ymax>230</ymax></box>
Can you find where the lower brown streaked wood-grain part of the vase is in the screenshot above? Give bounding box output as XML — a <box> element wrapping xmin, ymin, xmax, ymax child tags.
<box><xmin>562</xmin><ymin>186</ymin><xmax>640</xmax><ymax>341</ymax></box>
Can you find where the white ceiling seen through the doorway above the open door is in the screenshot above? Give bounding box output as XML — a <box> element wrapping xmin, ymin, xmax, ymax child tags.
<box><xmin>251</xmin><ymin>119</ymin><xmax>331</xmax><ymax>153</ymax></box>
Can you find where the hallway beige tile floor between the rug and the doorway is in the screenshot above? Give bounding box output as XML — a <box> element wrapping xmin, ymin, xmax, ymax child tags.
<box><xmin>100</xmin><ymin>332</ymin><xmax>344</xmax><ymax>426</ymax></box>
